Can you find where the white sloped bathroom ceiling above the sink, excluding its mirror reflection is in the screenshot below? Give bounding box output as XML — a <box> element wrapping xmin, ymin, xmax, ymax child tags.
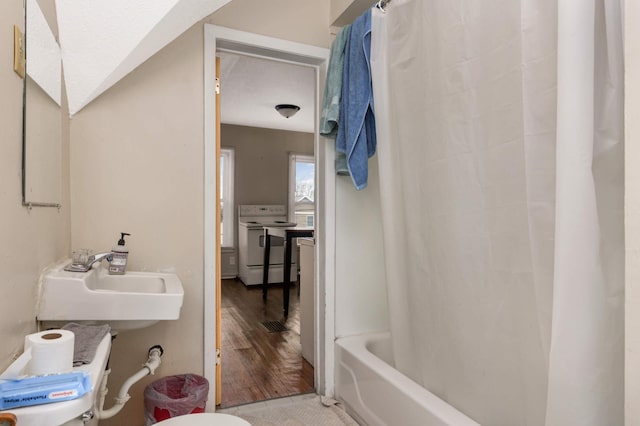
<box><xmin>56</xmin><ymin>0</ymin><xmax>231</xmax><ymax>115</ymax></box>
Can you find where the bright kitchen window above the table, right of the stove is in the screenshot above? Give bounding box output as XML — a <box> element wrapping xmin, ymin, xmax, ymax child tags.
<box><xmin>289</xmin><ymin>154</ymin><xmax>315</xmax><ymax>226</ymax></box>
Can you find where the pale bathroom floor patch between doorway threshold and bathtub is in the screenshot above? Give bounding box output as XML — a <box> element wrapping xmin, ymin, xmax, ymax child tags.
<box><xmin>216</xmin><ymin>394</ymin><xmax>358</xmax><ymax>426</ymax></box>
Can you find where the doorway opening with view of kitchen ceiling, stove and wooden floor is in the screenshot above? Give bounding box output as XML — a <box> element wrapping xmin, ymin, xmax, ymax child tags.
<box><xmin>216</xmin><ymin>49</ymin><xmax>316</xmax><ymax>408</ymax></box>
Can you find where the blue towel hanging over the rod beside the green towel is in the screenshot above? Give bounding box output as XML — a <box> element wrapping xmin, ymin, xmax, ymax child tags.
<box><xmin>336</xmin><ymin>9</ymin><xmax>376</xmax><ymax>190</ymax></box>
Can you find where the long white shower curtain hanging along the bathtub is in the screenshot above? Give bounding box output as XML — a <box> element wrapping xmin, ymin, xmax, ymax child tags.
<box><xmin>371</xmin><ymin>0</ymin><xmax>624</xmax><ymax>426</ymax></box>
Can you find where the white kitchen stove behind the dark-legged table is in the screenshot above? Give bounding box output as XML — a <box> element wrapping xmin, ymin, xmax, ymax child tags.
<box><xmin>238</xmin><ymin>204</ymin><xmax>298</xmax><ymax>285</ymax></box>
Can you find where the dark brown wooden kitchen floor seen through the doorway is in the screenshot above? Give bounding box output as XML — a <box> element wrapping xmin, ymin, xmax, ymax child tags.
<box><xmin>220</xmin><ymin>280</ymin><xmax>314</xmax><ymax>408</ymax></box>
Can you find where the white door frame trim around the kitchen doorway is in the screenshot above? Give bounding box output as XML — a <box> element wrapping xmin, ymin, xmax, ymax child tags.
<box><xmin>204</xmin><ymin>25</ymin><xmax>333</xmax><ymax>412</ymax></box>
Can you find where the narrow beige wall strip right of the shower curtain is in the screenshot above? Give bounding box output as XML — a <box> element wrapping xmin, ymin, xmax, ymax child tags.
<box><xmin>625</xmin><ymin>0</ymin><xmax>640</xmax><ymax>426</ymax></box>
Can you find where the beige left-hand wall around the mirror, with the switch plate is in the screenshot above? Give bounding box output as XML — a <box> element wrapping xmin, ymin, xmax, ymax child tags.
<box><xmin>0</xmin><ymin>0</ymin><xmax>69</xmax><ymax>370</ymax></box>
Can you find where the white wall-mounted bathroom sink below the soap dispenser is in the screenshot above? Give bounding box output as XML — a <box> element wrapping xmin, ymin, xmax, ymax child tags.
<box><xmin>37</xmin><ymin>261</ymin><xmax>184</xmax><ymax>330</ymax></box>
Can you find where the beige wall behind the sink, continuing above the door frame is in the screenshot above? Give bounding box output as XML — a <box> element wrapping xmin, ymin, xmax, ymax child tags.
<box><xmin>70</xmin><ymin>0</ymin><xmax>329</xmax><ymax>425</ymax></box>
